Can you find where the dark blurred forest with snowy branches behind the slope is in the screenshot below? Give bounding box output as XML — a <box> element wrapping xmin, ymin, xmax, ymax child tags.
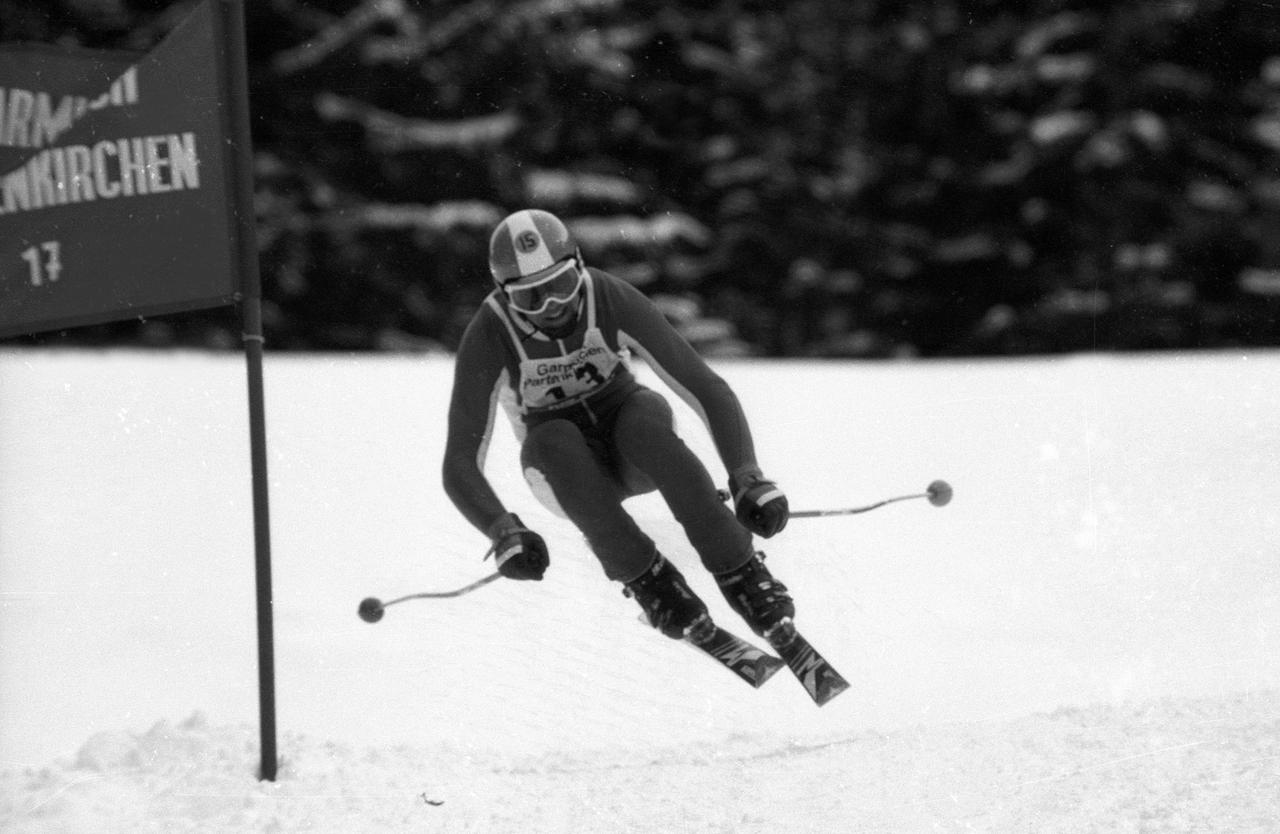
<box><xmin>0</xmin><ymin>0</ymin><xmax>1280</xmax><ymax>357</ymax></box>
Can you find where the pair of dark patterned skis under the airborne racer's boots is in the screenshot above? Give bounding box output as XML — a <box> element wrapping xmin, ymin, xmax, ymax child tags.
<box><xmin>685</xmin><ymin>620</ymin><xmax>849</xmax><ymax>706</ymax></box>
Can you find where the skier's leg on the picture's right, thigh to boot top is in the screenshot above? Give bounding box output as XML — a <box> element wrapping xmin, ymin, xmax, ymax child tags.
<box><xmin>613</xmin><ymin>389</ymin><xmax>751</xmax><ymax>573</ymax></box>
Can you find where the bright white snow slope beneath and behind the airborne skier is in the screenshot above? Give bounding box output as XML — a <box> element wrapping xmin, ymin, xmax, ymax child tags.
<box><xmin>0</xmin><ymin>352</ymin><xmax>1280</xmax><ymax>831</ymax></box>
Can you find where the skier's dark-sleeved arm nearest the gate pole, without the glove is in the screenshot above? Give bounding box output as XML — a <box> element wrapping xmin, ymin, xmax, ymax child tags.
<box><xmin>443</xmin><ymin>312</ymin><xmax>507</xmax><ymax>536</ymax></box>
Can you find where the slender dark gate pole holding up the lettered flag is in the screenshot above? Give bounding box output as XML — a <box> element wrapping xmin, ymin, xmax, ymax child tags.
<box><xmin>218</xmin><ymin>0</ymin><xmax>278</xmax><ymax>782</ymax></box>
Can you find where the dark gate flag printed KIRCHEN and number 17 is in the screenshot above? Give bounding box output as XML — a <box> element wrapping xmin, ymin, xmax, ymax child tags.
<box><xmin>0</xmin><ymin>0</ymin><xmax>239</xmax><ymax>336</ymax></box>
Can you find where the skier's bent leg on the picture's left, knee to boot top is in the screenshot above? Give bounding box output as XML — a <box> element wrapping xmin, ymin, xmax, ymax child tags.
<box><xmin>520</xmin><ymin>420</ymin><xmax>657</xmax><ymax>582</ymax></box>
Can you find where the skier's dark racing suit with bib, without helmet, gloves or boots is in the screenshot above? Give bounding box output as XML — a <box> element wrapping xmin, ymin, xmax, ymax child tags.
<box><xmin>443</xmin><ymin>267</ymin><xmax>758</xmax><ymax>582</ymax></box>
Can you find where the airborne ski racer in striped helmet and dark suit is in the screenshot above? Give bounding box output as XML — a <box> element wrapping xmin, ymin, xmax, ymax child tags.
<box><xmin>443</xmin><ymin>209</ymin><xmax>795</xmax><ymax>642</ymax></box>
